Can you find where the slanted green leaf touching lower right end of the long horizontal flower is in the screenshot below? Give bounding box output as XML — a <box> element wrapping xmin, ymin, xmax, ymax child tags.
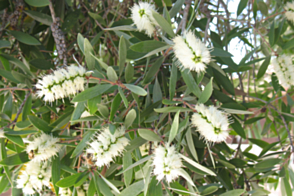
<box><xmin>72</xmin><ymin>84</ymin><xmax>112</xmax><ymax>102</ymax></box>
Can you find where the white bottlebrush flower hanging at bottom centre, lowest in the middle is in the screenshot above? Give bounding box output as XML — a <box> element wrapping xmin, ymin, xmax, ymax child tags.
<box><xmin>153</xmin><ymin>144</ymin><xmax>183</xmax><ymax>183</ymax></box>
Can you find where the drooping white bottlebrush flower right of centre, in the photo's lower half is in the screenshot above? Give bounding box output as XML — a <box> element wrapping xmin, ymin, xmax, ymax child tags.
<box><xmin>191</xmin><ymin>104</ymin><xmax>230</xmax><ymax>143</ymax></box>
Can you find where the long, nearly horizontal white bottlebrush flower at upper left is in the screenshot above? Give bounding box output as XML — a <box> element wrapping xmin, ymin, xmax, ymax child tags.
<box><xmin>36</xmin><ymin>65</ymin><xmax>91</xmax><ymax>102</ymax></box>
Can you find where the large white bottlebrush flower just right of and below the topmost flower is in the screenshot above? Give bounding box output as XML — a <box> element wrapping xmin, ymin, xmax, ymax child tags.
<box><xmin>173</xmin><ymin>31</ymin><xmax>211</xmax><ymax>73</ymax></box>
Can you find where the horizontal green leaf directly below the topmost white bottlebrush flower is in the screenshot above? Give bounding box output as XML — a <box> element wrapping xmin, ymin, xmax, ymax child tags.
<box><xmin>130</xmin><ymin>40</ymin><xmax>167</xmax><ymax>53</ymax></box>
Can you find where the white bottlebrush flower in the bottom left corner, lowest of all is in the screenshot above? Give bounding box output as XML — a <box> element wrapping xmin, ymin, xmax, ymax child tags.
<box><xmin>16</xmin><ymin>161</ymin><xmax>52</xmax><ymax>195</ymax></box>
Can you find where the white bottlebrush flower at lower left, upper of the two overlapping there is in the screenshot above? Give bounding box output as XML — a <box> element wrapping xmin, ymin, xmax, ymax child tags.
<box><xmin>26</xmin><ymin>133</ymin><xmax>61</xmax><ymax>162</ymax></box>
